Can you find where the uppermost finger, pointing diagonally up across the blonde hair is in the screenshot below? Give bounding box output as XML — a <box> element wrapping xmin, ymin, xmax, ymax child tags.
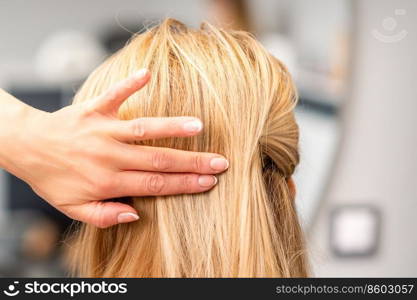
<box><xmin>93</xmin><ymin>69</ymin><xmax>150</xmax><ymax>115</ymax></box>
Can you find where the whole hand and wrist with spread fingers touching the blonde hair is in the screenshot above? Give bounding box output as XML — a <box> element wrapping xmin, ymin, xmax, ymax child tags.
<box><xmin>0</xmin><ymin>71</ymin><xmax>228</xmax><ymax>228</ymax></box>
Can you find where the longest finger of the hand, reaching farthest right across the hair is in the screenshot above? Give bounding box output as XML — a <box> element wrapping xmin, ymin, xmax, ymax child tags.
<box><xmin>115</xmin><ymin>144</ymin><xmax>229</xmax><ymax>174</ymax></box>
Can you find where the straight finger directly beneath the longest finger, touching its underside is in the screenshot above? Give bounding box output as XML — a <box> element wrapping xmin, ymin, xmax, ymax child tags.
<box><xmin>112</xmin><ymin>171</ymin><xmax>217</xmax><ymax>197</ymax></box>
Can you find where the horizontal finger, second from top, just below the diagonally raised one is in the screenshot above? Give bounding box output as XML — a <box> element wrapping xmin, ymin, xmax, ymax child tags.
<box><xmin>109</xmin><ymin>117</ymin><xmax>203</xmax><ymax>142</ymax></box>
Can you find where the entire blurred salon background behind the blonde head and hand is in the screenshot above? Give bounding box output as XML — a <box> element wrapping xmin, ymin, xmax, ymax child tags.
<box><xmin>0</xmin><ymin>0</ymin><xmax>417</xmax><ymax>277</ymax></box>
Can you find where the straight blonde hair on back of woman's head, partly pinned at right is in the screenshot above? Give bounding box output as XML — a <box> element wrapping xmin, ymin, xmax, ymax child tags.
<box><xmin>73</xmin><ymin>19</ymin><xmax>307</xmax><ymax>277</ymax></box>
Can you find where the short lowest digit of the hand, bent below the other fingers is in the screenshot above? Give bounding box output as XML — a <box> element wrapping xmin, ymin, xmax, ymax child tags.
<box><xmin>74</xmin><ymin>201</ymin><xmax>139</xmax><ymax>228</ymax></box>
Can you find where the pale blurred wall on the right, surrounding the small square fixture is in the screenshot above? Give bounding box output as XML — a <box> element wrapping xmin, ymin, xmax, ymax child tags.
<box><xmin>311</xmin><ymin>0</ymin><xmax>417</xmax><ymax>276</ymax></box>
